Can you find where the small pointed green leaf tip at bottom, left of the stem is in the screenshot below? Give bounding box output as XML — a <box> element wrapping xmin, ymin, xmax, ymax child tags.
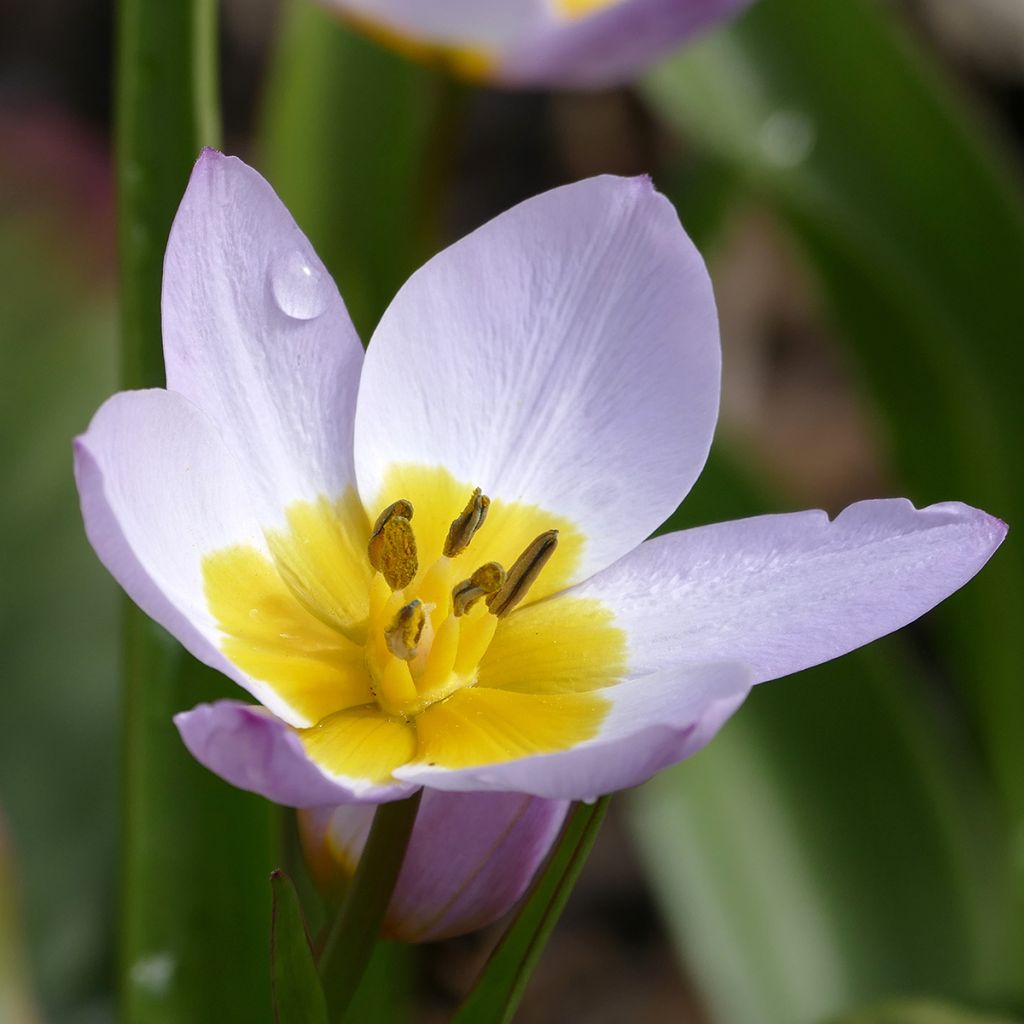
<box><xmin>270</xmin><ymin>870</ymin><xmax>328</xmax><ymax>1024</ymax></box>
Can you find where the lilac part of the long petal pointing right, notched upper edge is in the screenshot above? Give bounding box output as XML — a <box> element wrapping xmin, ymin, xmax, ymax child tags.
<box><xmin>573</xmin><ymin>499</ymin><xmax>1007</xmax><ymax>682</ymax></box>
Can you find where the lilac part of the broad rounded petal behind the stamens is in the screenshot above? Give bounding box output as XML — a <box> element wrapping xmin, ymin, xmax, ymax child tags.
<box><xmin>355</xmin><ymin>177</ymin><xmax>720</xmax><ymax>580</ymax></box>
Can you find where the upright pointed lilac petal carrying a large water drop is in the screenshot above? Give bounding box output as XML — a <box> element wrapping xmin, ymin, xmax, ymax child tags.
<box><xmin>163</xmin><ymin>150</ymin><xmax>362</xmax><ymax>526</ymax></box>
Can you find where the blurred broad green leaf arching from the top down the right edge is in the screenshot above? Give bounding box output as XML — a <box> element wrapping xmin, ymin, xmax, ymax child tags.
<box><xmin>645</xmin><ymin>0</ymin><xmax>1024</xmax><ymax>843</ymax></box>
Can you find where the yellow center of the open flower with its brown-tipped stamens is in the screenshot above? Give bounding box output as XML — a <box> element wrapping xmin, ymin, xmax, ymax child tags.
<box><xmin>195</xmin><ymin>466</ymin><xmax>626</xmax><ymax>781</ymax></box>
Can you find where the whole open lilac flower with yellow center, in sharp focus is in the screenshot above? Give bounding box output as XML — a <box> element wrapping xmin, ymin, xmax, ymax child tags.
<box><xmin>75</xmin><ymin>151</ymin><xmax>1006</xmax><ymax>823</ymax></box>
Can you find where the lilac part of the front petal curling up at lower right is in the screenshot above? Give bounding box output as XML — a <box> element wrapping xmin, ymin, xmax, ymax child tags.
<box><xmin>394</xmin><ymin>664</ymin><xmax>750</xmax><ymax>800</ymax></box>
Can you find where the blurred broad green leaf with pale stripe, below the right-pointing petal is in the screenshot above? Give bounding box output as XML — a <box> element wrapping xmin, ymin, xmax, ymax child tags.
<box><xmin>629</xmin><ymin>449</ymin><xmax>1007</xmax><ymax>1024</ymax></box>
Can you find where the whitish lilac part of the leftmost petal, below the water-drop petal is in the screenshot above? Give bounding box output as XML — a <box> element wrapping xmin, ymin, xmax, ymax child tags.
<box><xmin>75</xmin><ymin>390</ymin><xmax>305</xmax><ymax>724</ymax></box>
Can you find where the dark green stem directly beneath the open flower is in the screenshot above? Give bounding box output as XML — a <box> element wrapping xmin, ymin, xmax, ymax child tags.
<box><xmin>319</xmin><ymin>791</ymin><xmax>422</xmax><ymax>1022</ymax></box>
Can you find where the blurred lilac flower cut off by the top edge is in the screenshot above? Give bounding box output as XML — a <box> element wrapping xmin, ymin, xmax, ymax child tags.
<box><xmin>322</xmin><ymin>0</ymin><xmax>751</xmax><ymax>88</ymax></box>
